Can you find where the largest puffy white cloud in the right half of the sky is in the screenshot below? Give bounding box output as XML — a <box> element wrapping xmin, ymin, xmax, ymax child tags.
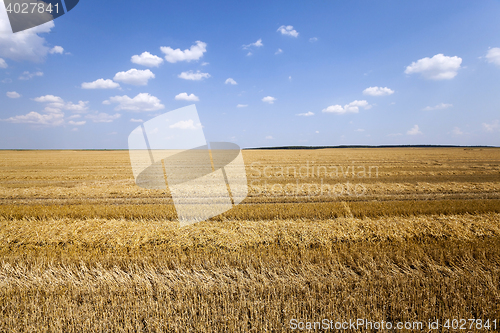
<box><xmin>405</xmin><ymin>53</ymin><xmax>462</xmax><ymax>80</ymax></box>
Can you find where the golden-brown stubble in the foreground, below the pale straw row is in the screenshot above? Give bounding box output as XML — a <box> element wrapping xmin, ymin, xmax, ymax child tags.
<box><xmin>0</xmin><ymin>239</ymin><xmax>500</xmax><ymax>332</ymax></box>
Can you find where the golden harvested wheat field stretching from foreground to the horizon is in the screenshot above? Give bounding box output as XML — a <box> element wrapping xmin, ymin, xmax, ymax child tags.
<box><xmin>0</xmin><ymin>148</ymin><xmax>500</xmax><ymax>332</ymax></box>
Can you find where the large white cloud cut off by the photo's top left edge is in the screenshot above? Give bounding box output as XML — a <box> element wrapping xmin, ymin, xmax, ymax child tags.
<box><xmin>0</xmin><ymin>5</ymin><xmax>54</xmax><ymax>62</ymax></box>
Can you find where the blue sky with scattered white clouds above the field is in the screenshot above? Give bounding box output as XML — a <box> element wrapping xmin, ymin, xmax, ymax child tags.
<box><xmin>0</xmin><ymin>0</ymin><xmax>500</xmax><ymax>149</ymax></box>
